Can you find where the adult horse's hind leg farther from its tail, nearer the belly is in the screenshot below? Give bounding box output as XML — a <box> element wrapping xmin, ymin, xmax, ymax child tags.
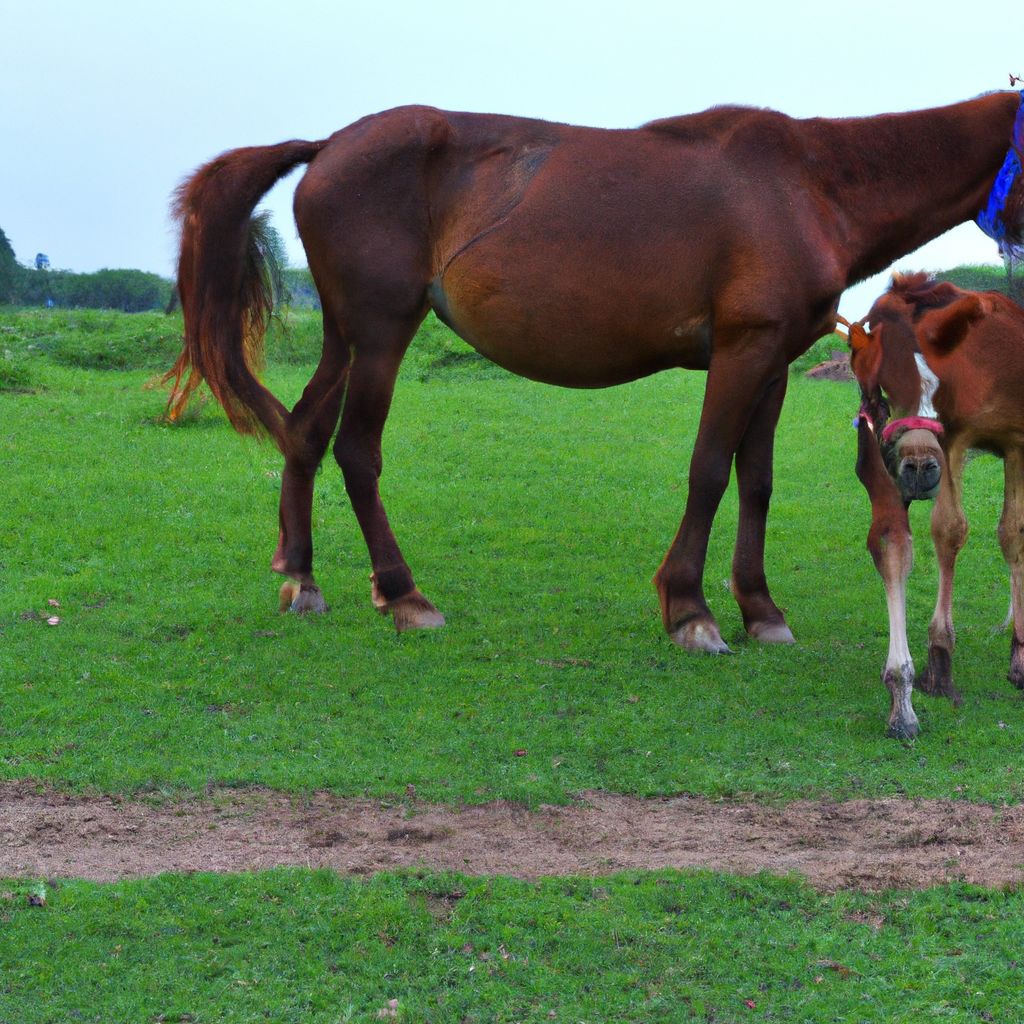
<box><xmin>334</xmin><ymin>313</ymin><xmax>444</xmax><ymax>632</ymax></box>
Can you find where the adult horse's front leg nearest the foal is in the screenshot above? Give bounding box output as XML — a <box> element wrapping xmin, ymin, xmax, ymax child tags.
<box><xmin>732</xmin><ymin>366</ymin><xmax>793</xmax><ymax>643</ymax></box>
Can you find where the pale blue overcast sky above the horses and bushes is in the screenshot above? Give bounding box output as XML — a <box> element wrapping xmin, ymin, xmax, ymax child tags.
<box><xmin>0</xmin><ymin>0</ymin><xmax>1024</xmax><ymax>316</ymax></box>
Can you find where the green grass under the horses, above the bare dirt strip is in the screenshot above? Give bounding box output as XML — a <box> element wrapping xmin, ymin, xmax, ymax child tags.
<box><xmin>0</xmin><ymin>307</ymin><xmax>1024</xmax><ymax>804</ymax></box>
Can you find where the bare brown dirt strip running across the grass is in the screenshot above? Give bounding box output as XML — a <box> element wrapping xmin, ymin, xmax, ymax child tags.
<box><xmin>0</xmin><ymin>782</ymin><xmax>1024</xmax><ymax>891</ymax></box>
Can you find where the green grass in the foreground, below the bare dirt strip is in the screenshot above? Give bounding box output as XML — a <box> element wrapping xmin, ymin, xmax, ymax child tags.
<box><xmin>0</xmin><ymin>870</ymin><xmax>1024</xmax><ymax>1024</ymax></box>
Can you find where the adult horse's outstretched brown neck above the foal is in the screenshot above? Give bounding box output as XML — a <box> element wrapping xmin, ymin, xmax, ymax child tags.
<box><xmin>816</xmin><ymin>92</ymin><xmax>1020</xmax><ymax>284</ymax></box>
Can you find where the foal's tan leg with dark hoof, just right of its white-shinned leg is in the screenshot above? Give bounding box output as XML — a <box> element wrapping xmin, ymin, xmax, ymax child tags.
<box><xmin>914</xmin><ymin>437</ymin><xmax>968</xmax><ymax>705</ymax></box>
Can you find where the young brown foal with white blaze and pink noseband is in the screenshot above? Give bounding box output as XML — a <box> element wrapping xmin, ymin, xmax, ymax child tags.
<box><xmin>850</xmin><ymin>273</ymin><xmax>1024</xmax><ymax>737</ymax></box>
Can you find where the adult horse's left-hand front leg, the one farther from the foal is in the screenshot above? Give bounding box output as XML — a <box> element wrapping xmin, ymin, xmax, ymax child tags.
<box><xmin>654</xmin><ymin>331</ymin><xmax>785</xmax><ymax>654</ymax></box>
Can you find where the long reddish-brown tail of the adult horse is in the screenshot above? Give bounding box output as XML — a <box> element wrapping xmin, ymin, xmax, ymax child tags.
<box><xmin>164</xmin><ymin>140</ymin><xmax>325</xmax><ymax>449</ymax></box>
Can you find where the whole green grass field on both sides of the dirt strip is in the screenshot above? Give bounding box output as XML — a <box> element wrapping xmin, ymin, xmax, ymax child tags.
<box><xmin>0</xmin><ymin>311</ymin><xmax>1024</xmax><ymax>1024</ymax></box>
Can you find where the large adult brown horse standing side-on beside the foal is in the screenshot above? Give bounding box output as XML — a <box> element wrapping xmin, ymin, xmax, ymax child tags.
<box><xmin>163</xmin><ymin>92</ymin><xmax>1020</xmax><ymax>652</ymax></box>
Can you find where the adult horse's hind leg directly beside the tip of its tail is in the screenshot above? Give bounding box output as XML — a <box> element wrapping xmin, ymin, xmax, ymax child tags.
<box><xmin>270</xmin><ymin>311</ymin><xmax>348</xmax><ymax>613</ymax></box>
